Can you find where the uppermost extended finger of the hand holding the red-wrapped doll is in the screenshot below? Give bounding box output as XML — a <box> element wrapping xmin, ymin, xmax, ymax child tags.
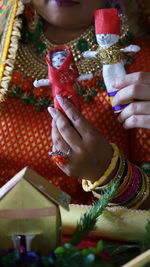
<box><xmin>57</xmin><ymin>96</ymin><xmax>97</xmax><ymax>140</ymax></box>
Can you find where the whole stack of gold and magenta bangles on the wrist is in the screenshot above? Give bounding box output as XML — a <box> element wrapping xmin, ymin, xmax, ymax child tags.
<box><xmin>82</xmin><ymin>144</ymin><xmax>150</xmax><ymax>209</ymax></box>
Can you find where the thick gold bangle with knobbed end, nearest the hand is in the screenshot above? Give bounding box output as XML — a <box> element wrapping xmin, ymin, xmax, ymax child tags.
<box><xmin>82</xmin><ymin>143</ymin><xmax>119</xmax><ymax>192</ymax></box>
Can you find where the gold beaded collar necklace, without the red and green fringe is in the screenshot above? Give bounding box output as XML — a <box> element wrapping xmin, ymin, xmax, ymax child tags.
<box><xmin>16</xmin><ymin>26</ymin><xmax>102</xmax><ymax>79</ymax></box>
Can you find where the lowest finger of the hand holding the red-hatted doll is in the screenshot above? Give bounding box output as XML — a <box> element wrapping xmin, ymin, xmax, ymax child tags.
<box><xmin>123</xmin><ymin>115</ymin><xmax>150</xmax><ymax>129</ymax></box>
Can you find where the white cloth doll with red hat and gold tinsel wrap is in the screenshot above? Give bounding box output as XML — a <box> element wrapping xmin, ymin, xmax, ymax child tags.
<box><xmin>83</xmin><ymin>8</ymin><xmax>140</xmax><ymax>113</ymax></box>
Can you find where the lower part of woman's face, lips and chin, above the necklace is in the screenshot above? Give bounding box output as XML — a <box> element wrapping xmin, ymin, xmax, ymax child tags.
<box><xmin>31</xmin><ymin>0</ymin><xmax>106</xmax><ymax>29</ymax></box>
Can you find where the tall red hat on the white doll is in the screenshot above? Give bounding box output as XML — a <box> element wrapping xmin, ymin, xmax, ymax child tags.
<box><xmin>94</xmin><ymin>8</ymin><xmax>120</xmax><ymax>35</ymax></box>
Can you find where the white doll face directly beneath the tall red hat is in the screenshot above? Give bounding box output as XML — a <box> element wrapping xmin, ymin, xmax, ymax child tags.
<box><xmin>96</xmin><ymin>34</ymin><xmax>119</xmax><ymax>47</ymax></box>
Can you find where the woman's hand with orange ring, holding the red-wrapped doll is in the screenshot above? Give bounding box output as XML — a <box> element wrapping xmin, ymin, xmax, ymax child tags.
<box><xmin>48</xmin><ymin>96</ymin><xmax>113</xmax><ymax>181</ymax></box>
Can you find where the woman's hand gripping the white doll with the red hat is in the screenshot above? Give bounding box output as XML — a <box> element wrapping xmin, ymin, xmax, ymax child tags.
<box><xmin>112</xmin><ymin>72</ymin><xmax>150</xmax><ymax>129</ymax></box>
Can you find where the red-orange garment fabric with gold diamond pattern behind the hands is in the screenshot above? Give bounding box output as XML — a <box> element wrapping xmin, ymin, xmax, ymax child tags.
<box><xmin>0</xmin><ymin>38</ymin><xmax>150</xmax><ymax>204</ymax></box>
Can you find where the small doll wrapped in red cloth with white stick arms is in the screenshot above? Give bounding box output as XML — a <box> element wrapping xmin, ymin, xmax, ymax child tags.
<box><xmin>34</xmin><ymin>45</ymin><xmax>91</xmax><ymax>113</ymax></box>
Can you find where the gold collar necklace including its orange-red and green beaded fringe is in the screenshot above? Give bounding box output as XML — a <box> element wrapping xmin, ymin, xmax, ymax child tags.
<box><xmin>9</xmin><ymin>20</ymin><xmax>130</xmax><ymax>110</ymax></box>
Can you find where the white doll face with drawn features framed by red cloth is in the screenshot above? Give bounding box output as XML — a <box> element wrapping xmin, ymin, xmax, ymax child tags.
<box><xmin>51</xmin><ymin>51</ymin><xmax>67</xmax><ymax>69</ymax></box>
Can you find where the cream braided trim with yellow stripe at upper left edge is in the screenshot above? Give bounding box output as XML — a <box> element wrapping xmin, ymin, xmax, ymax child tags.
<box><xmin>0</xmin><ymin>0</ymin><xmax>24</xmax><ymax>101</ymax></box>
